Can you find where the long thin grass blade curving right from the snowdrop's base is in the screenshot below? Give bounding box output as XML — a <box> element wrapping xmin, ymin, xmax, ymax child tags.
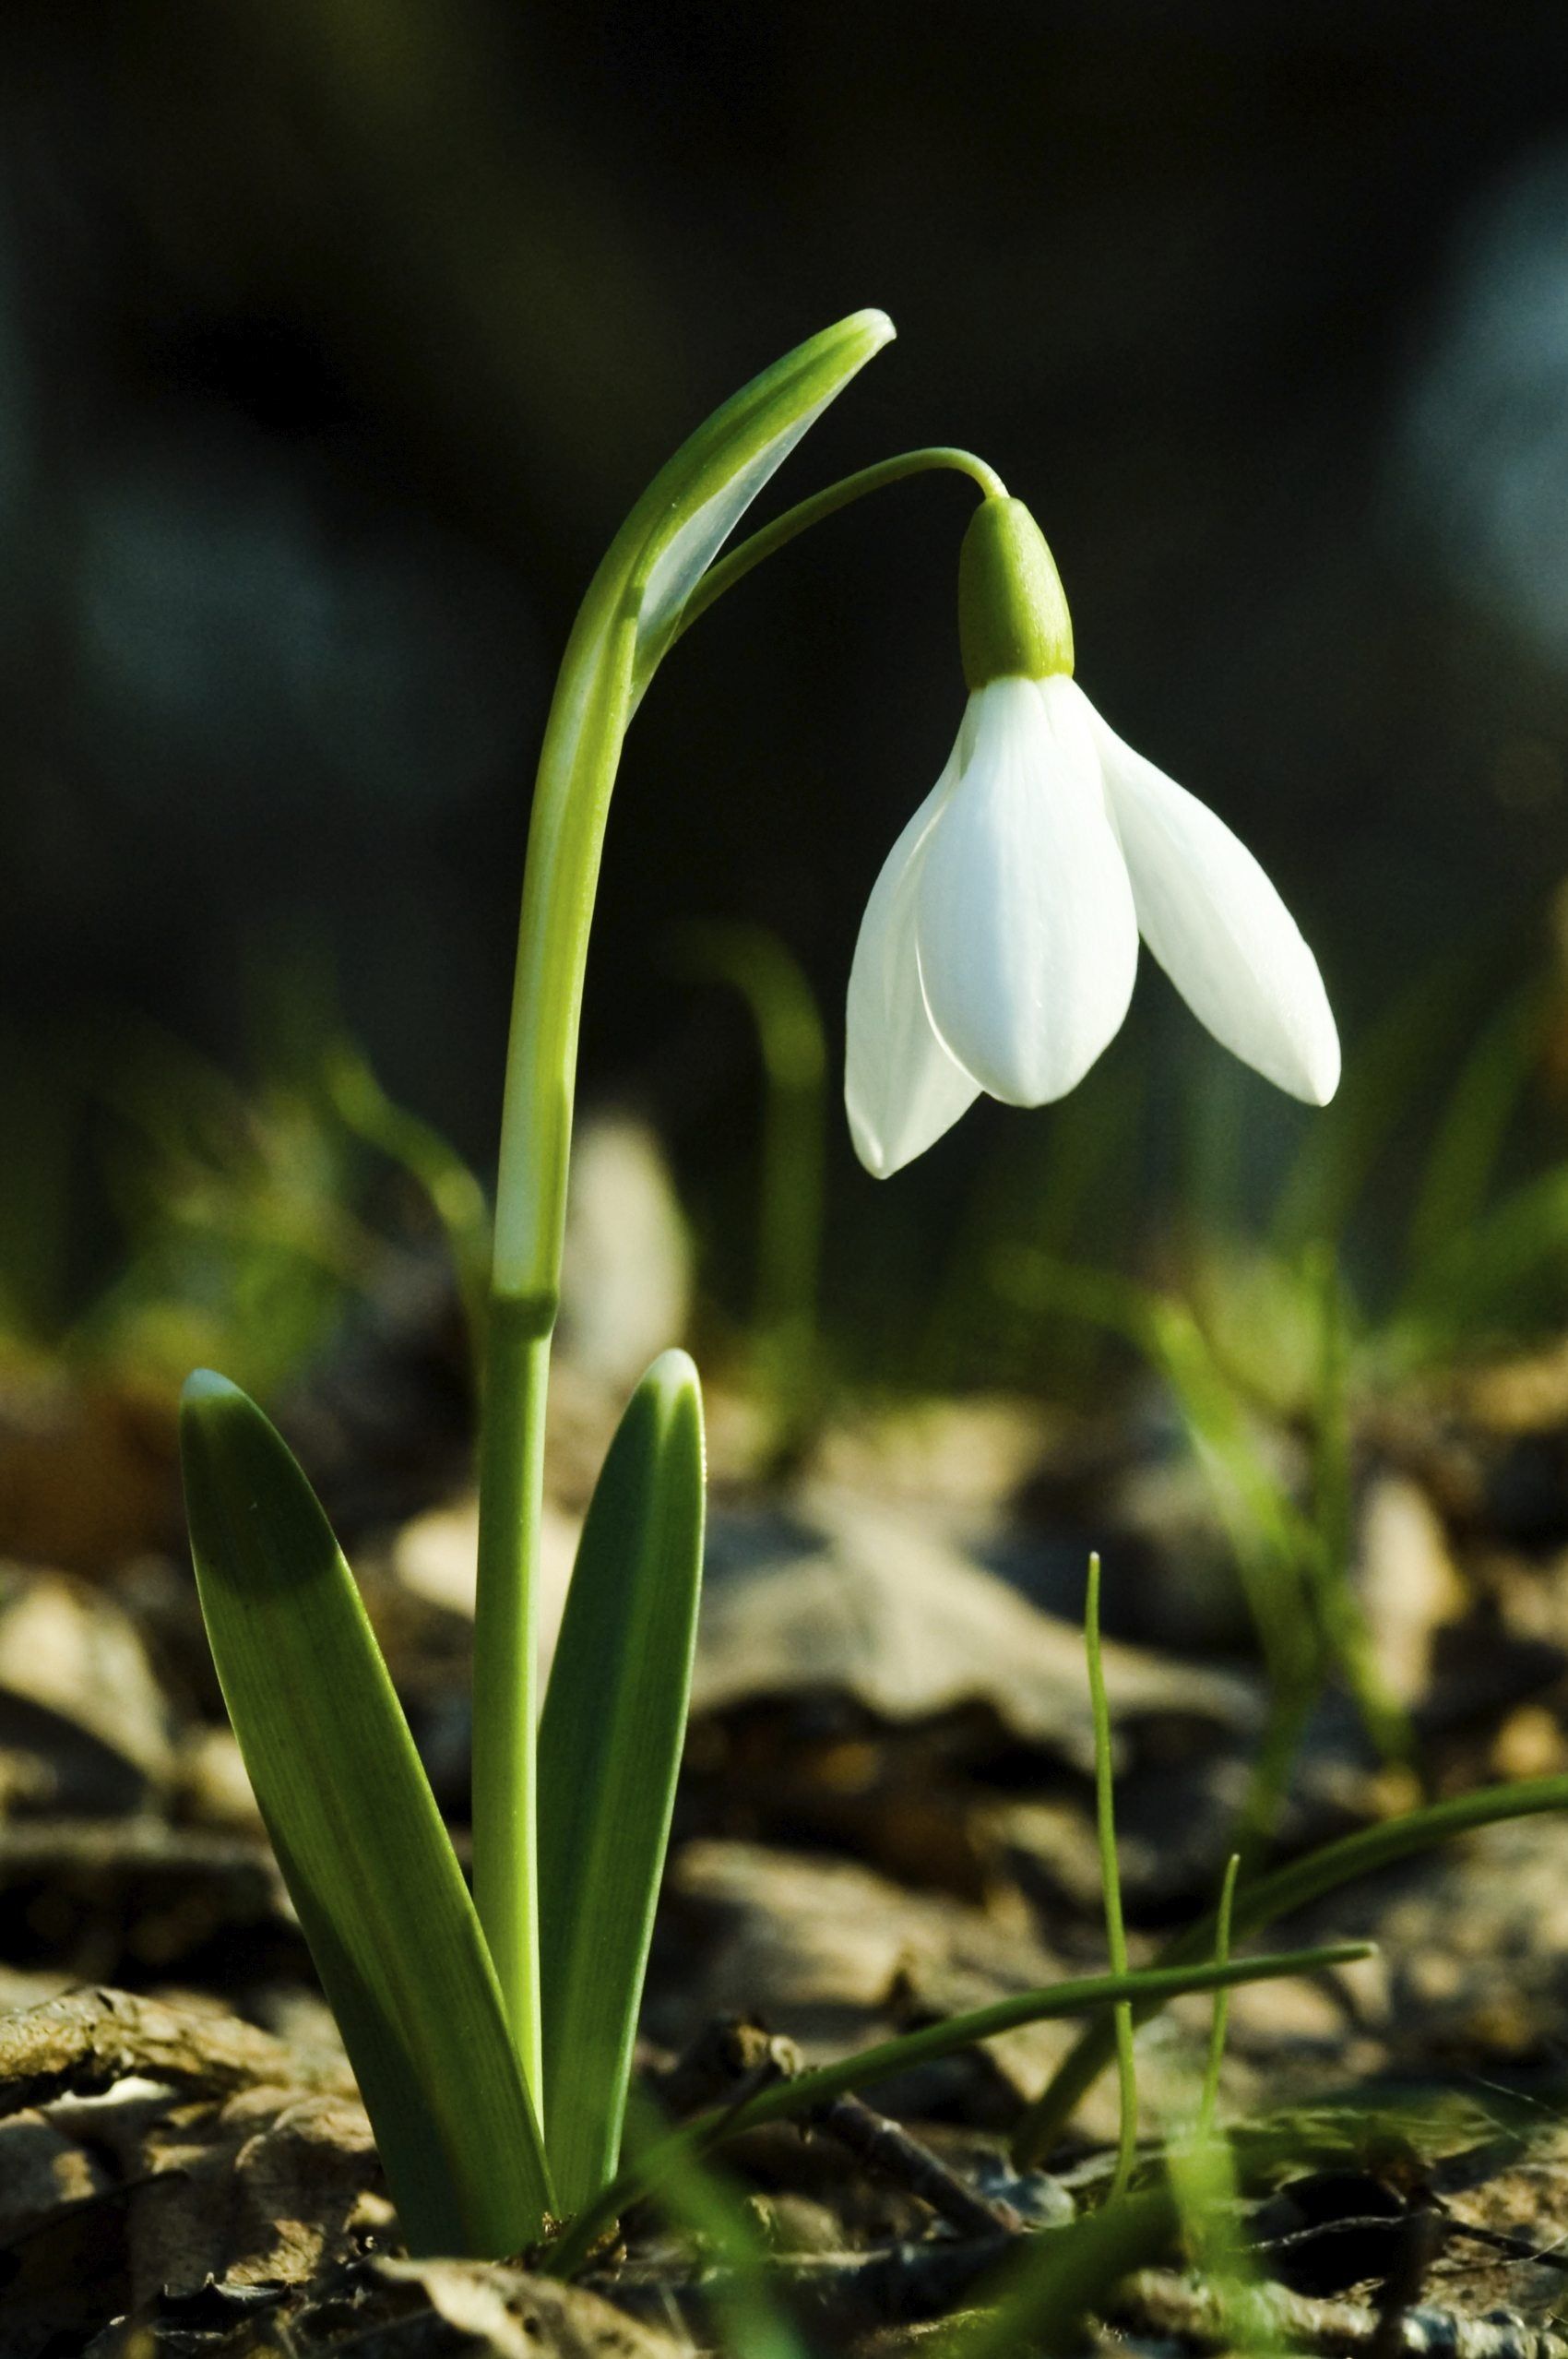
<box><xmin>540</xmin><ymin>1941</ymin><xmax>1372</xmax><ymax>2277</ymax></box>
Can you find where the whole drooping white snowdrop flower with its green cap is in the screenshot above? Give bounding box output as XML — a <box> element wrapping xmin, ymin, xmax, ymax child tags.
<box><xmin>844</xmin><ymin>498</ymin><xmax>1339</xmax><ymax>1180</ymax></box>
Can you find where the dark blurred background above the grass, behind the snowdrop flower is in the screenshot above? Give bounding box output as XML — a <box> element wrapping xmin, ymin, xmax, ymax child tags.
<box><xmin>0</xmin><ymin>0</ymin><xmax>1568</xmax><ymax>1358</ymax></box>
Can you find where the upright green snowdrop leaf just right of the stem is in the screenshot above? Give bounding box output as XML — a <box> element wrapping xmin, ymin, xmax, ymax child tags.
<box><xmin>540</xmin><ymin>1352</ymin><xmax>703</xmax><ymax>2210</ymax></box>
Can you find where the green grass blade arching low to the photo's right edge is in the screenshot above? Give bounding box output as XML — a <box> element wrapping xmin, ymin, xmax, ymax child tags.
<box><xmin>1014</xmin><ymin>1776</ymin><xmax>1568</xmax><ymax>2165</ymax></box>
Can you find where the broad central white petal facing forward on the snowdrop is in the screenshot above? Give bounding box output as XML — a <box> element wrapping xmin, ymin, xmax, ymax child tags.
<box><xmin>917</xmin><ymin>679</ymin><xmax>1139</xmax><ymax>1106</ymax></box>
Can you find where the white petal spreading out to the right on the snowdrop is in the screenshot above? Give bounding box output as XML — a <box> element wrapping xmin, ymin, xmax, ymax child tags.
<box><xmin>1080</xmin><ymin>691</ymin><xmax>1339</xmax><ymax>1106</ymax></box>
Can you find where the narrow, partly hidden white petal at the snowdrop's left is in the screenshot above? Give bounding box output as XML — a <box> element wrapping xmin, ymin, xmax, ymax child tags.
<box><xmin>844</xmin><ymin>755</ymin><xmax>980</xmax><ymax>1180</ymax></box>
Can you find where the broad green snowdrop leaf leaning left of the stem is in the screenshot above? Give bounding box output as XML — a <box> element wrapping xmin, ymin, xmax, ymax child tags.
<box><xmin>182</xmin><ymin>1371</ymin><xmax>552</xmax><ymax>2260</ymax></box>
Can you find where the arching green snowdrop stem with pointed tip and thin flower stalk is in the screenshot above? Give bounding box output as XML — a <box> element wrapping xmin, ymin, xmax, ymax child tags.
<box><xmin>474</xmin><ymin>312</ymin><xmax>1002</xmax><ymax>2121</ymax></box>
